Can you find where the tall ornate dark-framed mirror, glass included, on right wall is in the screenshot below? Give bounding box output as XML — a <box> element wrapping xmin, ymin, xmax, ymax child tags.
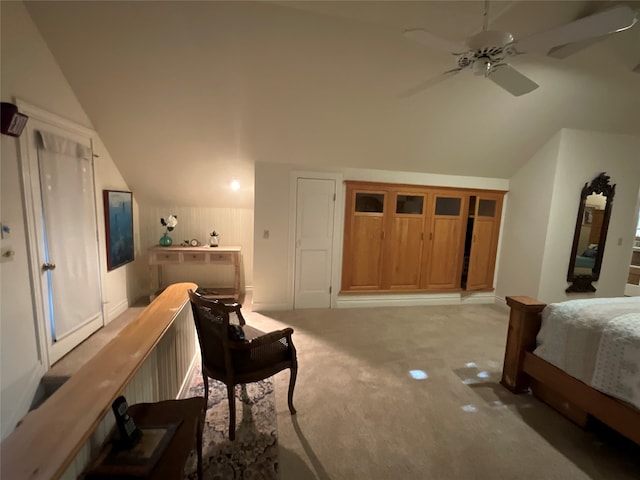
<box><xmin>565</xmin><ymin>172</ymin><xmax>616</xmax><ymax>293</ymax></box>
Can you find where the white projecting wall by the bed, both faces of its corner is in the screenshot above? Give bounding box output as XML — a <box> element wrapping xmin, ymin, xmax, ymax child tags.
<box><xmin>496</xmin><ymin>129</ymin><xmax>640</xmax><ymax>303</ymax></box>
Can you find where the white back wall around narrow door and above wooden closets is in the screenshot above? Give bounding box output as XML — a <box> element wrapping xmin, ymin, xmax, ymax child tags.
<box><xmin>253</xmin><ymin>162</ymin><xmax>509</xmax><ymax>310</ymax></box>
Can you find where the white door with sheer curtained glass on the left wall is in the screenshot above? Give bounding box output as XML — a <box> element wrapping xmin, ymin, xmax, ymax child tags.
<box><xmin>22</xmin><ymin>113</ymin><xmax>104</xmax><ymax>365</ymax></box>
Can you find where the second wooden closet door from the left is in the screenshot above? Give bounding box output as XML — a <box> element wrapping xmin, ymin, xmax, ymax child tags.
<box><xmin>382</xmin><ymin>191</ymin><xmax>426</xmax><ymax>290</ymax></box>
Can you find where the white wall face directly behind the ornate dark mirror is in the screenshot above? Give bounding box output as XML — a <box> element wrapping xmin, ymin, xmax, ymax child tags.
<box><xmin>537</xmin><ymin>129</ymin><xmax>640</xmax><ymax>303</ymax></box>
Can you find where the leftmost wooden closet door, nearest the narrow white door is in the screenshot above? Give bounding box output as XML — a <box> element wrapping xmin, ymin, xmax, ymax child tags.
<box><xmin>341</xmin><ymin>187</ymin><xmax>388</xmax><ymax>291</ymax></box>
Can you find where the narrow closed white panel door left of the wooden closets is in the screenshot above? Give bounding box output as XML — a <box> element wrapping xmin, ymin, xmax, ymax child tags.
<box><xmin>294</xmin><ymin>178</ymin><xmax>336</xmax><ymax>308</ymax></box>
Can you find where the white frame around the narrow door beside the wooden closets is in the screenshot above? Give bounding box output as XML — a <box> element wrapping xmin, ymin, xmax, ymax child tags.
<box><xmin>287</xmin><ymin>170</ymin><xmax>344</xmax><ymax>308</ymax></box>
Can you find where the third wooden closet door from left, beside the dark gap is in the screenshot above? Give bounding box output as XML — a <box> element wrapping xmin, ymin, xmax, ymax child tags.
<box><xmin>422</xmin><ymin>193</ymin><xmax>467</xmax><ymax>290</ymax></box>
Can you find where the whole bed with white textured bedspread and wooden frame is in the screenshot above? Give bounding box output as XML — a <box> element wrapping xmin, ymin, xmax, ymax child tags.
<box><xmin>500</xmin><ymin>297</ymin><xmax>640</xmax><ymax>445</ymax></box>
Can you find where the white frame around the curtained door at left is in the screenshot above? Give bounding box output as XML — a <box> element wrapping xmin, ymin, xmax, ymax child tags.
<box><xmin>15</xmin><ymin>98</ymin><xmax>105</xmax><ymax>371</ymax></box>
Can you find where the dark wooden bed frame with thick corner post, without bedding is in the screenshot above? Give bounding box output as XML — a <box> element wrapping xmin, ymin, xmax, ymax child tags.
<box><xmin>500</xmin><ymin>297</ymin><xmax>640</xmax><ymax>445</ymax></box>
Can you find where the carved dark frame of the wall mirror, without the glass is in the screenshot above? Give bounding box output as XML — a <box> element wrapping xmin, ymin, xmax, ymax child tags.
<box><xmin>565</xmin><ymin>172</ymin><xmax>616</xmax><ymax>293</ymax></box>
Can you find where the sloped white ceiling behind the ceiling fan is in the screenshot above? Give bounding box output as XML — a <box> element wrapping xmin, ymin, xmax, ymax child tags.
<box><xmin>27</xmin><ymin>1</ymin><xmax>640</xmax><ymax>207</ymax></box>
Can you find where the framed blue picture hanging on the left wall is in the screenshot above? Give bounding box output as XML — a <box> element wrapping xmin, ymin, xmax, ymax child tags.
<box><xmin>102</xmin><ymin>190</ymin><xmax>133</xmax><ymax>271</ymax></box>
